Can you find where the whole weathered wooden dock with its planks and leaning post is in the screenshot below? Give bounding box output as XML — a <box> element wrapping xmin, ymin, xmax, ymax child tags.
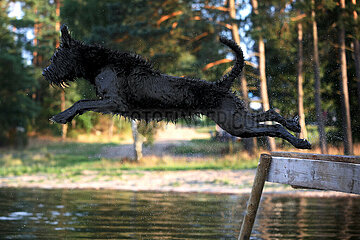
<box><xmin>238</xmin><ymin>152</ymin><xmax>360</xmax><ymax>240</ymax></box>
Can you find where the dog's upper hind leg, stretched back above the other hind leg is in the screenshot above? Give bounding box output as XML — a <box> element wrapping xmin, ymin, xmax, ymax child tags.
<box><xmin>251</xmin><ymin>109</ymin><xmax>301</xmax><ymax>132</ymax></box>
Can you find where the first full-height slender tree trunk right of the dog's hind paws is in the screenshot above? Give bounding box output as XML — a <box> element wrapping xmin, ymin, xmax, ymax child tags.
<box><xmin>311</xmin><ymin>0</ymin><xmax>327</xmax><ymax>154</ymax></box>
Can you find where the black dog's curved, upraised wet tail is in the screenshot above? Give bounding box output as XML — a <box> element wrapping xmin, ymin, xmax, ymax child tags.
<box><xmin>216</xmin><ymin>36</ymin><xmax>244</xmax><ymax>89</ymax></box>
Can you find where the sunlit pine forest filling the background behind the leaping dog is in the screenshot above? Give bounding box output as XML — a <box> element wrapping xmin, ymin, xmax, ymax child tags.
<box><xmin>0</xmin><ymin>0</ymin><xmax>360</xmax><ymax>155</ymax></box>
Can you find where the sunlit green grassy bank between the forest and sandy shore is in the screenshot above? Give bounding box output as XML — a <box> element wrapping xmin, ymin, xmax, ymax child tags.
<box><xmin>0</xmin><ymin>141</ymin><xmax>257</xmax><ymax>177</ymax></box>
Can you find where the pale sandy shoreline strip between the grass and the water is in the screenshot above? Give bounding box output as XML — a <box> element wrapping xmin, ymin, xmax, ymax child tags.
<box><xmin>0</xmin><ymin>169</ymin><xmax>360</xmax><ymax>197</ymax></box>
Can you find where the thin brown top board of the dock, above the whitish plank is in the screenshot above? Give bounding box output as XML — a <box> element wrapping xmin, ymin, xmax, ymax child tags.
<box><xmin>271</xmin><ymin>152</ymin><xmax>360</xmax><ymax>164</ymax></box>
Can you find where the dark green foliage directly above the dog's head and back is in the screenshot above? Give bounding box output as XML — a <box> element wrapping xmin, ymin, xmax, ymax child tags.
<box><xmin>61</xmin><ymin>0</ymin><xmax>231</xmax><ymax>81</ymax></box>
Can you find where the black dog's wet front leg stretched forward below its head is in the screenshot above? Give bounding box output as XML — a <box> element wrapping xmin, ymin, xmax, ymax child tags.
<box><xmin>50</xmin><ymin>99</ymin><xmax>125</xmax><ymax>124</ymax></box>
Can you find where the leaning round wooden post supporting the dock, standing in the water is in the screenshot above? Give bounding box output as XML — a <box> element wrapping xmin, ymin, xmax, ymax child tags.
<box><xmin>238</xmin><ymin>154</ymin><xmax>271</xmax><ymax>240</ymax></box>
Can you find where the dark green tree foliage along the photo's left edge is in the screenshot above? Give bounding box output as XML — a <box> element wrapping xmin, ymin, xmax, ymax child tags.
<box><xmin>0</xmin><ymin>2</ymin><xmax>38</xmax><ymax>146</ymax></box>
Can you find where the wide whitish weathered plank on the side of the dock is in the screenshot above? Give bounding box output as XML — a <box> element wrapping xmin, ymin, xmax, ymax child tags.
<box><xmin>266</xmin><ymin>156</ymin><xmax>360</xmax><ymax>194</ymax></box>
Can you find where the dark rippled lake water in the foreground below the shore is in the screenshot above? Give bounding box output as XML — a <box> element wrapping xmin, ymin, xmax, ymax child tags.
<box><xmin>0</xmin><ymin>188</ymin><xmax>360</xmax><ymax>239</ymax></box>
